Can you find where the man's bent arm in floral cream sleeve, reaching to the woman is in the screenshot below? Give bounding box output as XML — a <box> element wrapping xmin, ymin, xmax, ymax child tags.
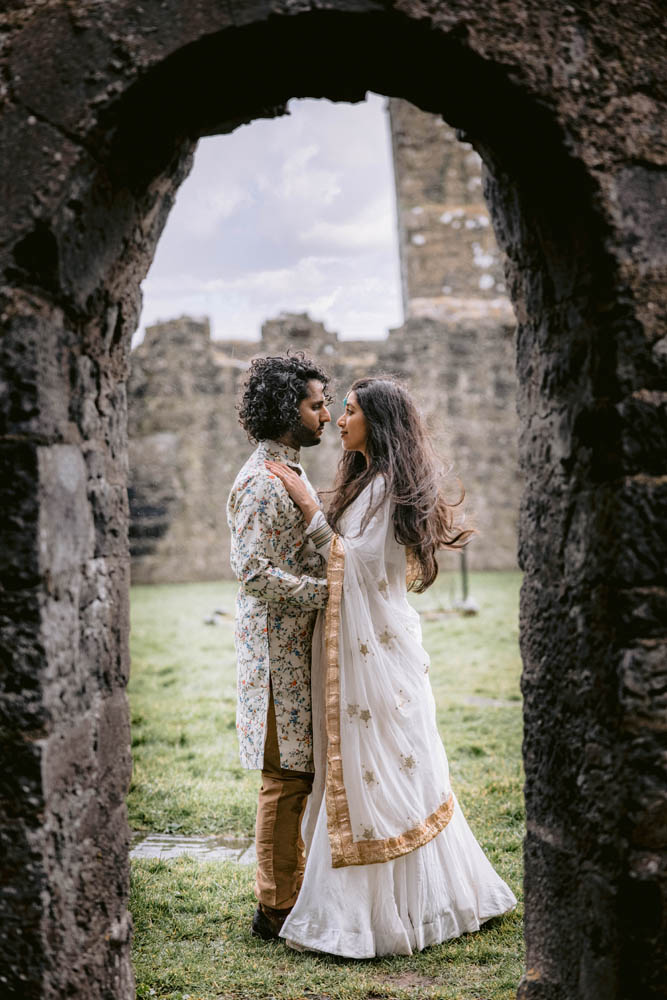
<box><xmin>230</xmin><ymin>473</ymin><xmax>328</xmax><ymax>610</ymax></box>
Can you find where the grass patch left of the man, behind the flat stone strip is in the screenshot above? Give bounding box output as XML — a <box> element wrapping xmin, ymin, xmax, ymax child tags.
<box><xmin>128</xmin><ymin>581</ymin><xmax>259</xmax><ymax>834</ymax></box>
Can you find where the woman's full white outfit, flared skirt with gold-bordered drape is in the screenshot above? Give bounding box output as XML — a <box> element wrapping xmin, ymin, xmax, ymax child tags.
<box><xmin>281</xmin><ymin>478</ymin><xmax>516</xmax><ymax>958</ymax></box>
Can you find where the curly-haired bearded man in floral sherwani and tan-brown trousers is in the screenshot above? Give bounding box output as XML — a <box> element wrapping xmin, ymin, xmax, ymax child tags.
<box><xmin>227</xmin><ymin>353</ymin><xmax>331</xmax><ymax>939</ymax></box>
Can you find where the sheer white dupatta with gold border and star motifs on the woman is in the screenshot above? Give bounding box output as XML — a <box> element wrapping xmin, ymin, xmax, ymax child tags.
<box><xmin>325</xmin><ymin>487</ymin><xmax>454</xmax><ymax>868</ymax></box>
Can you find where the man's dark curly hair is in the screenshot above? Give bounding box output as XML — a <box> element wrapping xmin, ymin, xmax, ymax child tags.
<box><xmin>238</xmin><ymin>351</ymin><xmax>331</xmax><ymax>441</ymax></box>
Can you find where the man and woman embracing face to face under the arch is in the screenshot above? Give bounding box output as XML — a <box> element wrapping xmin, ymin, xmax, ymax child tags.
<box><xmin>228</xmin><ymin>354</ymin><xmax>516</xmax><ymax>958</ymax></box>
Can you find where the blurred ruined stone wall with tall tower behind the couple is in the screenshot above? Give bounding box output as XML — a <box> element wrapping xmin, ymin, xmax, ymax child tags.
<box><xmin>128</xmin><ymin>100</ymin><xmax>520</xmax><ymax>582</ymax></box>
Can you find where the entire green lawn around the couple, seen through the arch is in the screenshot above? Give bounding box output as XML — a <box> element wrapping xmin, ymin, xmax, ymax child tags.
<box><xmin>128</xmin><ymin>573</ymin><xmax>523</xmax><ymax>1000</ymax></box>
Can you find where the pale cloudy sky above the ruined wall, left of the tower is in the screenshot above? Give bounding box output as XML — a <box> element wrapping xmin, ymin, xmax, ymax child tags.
<box><xmin>135</xmin><ymin>94</ymin><xmax>402</xmax><ymax>342</ymax></box>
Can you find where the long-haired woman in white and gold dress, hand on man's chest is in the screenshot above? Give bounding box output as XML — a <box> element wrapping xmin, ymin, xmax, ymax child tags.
<box><xmin>267</xmin><ymin>378</ymin><xmax>516</xmax><ymax>958</ymax></box>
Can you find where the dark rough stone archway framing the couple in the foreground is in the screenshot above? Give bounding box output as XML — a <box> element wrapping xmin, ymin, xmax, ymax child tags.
<box><xmin>0</xmin><ymin>0</ymin><xmax>667</xmax><ymax>1000</ymax></box>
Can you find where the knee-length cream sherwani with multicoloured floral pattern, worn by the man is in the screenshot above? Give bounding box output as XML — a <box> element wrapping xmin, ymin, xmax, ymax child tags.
<box><xmin>227</xmin><ymin>441</ymin><xmax>327</xmax><ymax>771</ymax></box>
